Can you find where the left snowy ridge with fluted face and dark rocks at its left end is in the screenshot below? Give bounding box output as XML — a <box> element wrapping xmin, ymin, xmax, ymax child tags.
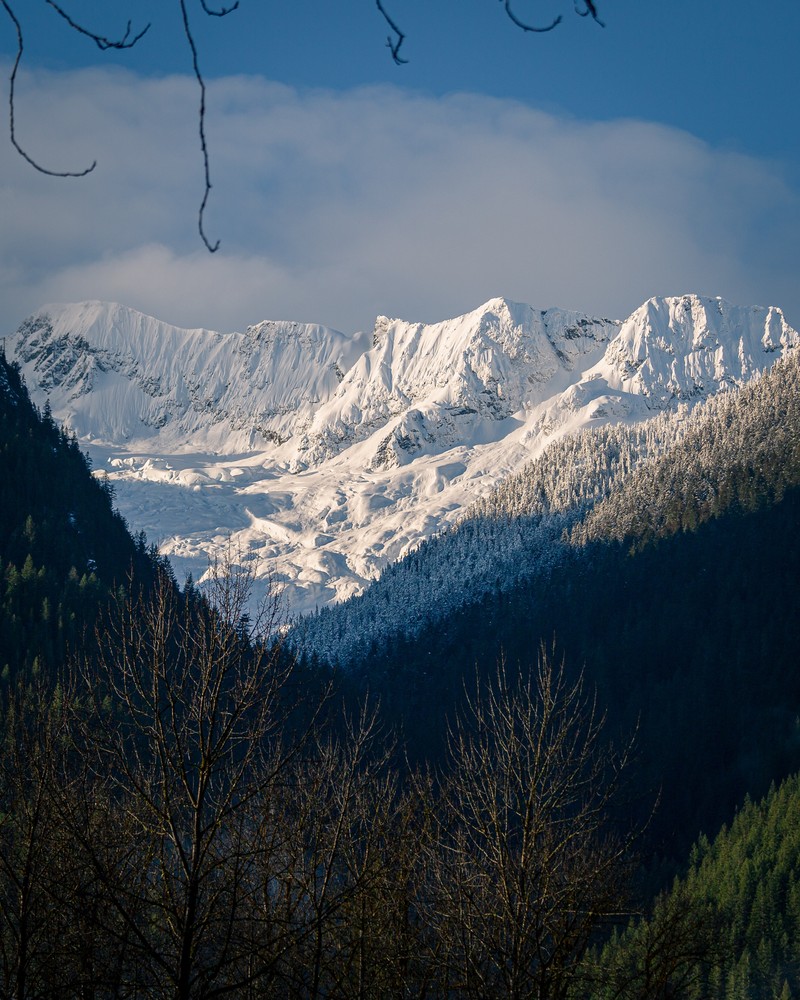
<box><xmin>9</xmin><ymin>302</ymin><xmax>372</xmax><ymax>454</ymax></box>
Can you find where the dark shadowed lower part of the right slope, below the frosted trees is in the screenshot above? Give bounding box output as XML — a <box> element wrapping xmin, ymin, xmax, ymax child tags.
<box><xmin>348</xmin><ymin>490</ymin><xmax>800</xmax><ymax>857</ymax></box>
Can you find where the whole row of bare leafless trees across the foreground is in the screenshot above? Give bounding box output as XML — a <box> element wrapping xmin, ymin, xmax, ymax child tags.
<box><xmin>0</xmin><ymin>573</ymin><xmax>636</xmax><ymax>1000</ymax></box>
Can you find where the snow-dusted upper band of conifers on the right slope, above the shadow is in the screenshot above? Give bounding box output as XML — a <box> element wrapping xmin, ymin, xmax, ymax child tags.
<box><xmin>292</xmin><ymin>340</ymin><xmax>800</xmax><ymax>668</ymax></box>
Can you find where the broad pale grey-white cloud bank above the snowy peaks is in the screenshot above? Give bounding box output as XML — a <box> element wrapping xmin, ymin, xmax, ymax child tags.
<box><xmin>0</xmin><ymin>70</ymin><xmax>800</xmax><ymax>330</ymax></box>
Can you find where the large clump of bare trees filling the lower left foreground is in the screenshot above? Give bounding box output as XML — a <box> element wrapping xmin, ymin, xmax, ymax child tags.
<box><xmin>0</xmin><ymin>552</ymin><xmax>440</xmax><ymax>1000</ymax></box>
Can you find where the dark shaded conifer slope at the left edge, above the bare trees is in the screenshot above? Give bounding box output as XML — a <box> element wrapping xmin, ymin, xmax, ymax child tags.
<box><xmin>0</xmin><ymin>348</ymin><xmax>153</xmax><ymax>683</ymax></box>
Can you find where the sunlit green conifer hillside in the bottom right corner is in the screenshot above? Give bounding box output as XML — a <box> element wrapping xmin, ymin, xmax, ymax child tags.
<box><xmin>590</xmin><ymin>776</ymin><xmax>800</xmax><ymax>1000</ymax></box>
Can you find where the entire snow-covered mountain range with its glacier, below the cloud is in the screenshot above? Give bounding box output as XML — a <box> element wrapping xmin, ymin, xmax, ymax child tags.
<box><xmin>6</xmin><ymin>296</ymin><xmax>800</xmax><ymax>614</ymax></box>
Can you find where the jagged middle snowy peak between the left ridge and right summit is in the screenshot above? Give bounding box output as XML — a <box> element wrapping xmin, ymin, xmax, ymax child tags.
<box><xmin>288</xmin><ymin>299</ymin><xmax>619</xmax><ymax>469</ymax></box>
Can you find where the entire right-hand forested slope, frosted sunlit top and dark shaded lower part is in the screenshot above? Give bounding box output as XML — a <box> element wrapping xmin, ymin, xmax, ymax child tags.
<box><xmin>311</xmin><ymin>350</ymin><xmax>800</xmax><ymax>858</ymax></box>
